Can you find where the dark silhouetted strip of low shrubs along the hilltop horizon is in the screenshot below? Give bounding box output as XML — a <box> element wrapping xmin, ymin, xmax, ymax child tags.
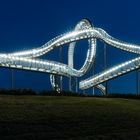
<box><xmin>0</xmin><ymin>89</ymin><xmax>140</xmax><ymax>99</ymax></box>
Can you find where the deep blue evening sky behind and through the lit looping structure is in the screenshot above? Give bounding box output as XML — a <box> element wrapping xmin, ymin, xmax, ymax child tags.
<box><xmin>0</xmin><ymin>0</ymin><xmax>140</xmax><ymax>93</ymax></box>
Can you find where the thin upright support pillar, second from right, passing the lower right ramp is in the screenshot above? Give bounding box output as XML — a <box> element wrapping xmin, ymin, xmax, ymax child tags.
<box><xmin>104</xmin><ymin>43</ymin><xmax>108</xmax><ymax>95</ymax></box>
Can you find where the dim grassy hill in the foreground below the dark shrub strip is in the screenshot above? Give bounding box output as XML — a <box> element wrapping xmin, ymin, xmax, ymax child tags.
<box><xmin>0</xmin><ymin>95</ymin><xmax>140</xmax><ymax>140</ymax></box>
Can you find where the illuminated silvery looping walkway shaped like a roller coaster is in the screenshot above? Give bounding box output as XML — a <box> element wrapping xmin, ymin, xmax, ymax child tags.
<box><xmin>0</xmin><ymin>19</ymin><xmax>140</xmax><ymax>94</ymax></box>
